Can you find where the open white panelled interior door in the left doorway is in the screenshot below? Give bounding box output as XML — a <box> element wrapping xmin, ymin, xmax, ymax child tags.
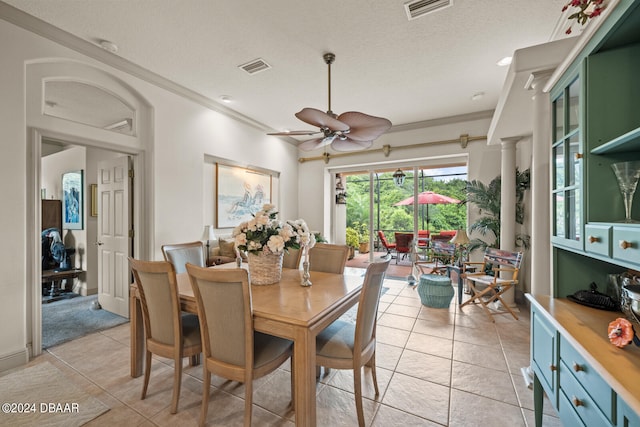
<box><xmin>96</xmin><ymin>156</ymin><xmax>132</xmax><ymax>318</ymax></box>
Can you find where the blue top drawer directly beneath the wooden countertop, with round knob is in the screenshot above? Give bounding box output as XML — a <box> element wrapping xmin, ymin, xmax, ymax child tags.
<box><xmin>560</xmin><ymin>336</ymin><xmax>615</xmax><ymax>420</ymax></box>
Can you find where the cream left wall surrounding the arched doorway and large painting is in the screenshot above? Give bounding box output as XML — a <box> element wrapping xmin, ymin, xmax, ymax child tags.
<box><xmin>0</xmin><ymin>16</ymin><xmax>298</xmax><ymax>371</ymax></box>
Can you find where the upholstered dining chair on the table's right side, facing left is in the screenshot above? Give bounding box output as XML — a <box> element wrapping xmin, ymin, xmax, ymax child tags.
<box><xmin>316</xmin><ymin>259</ymin><xmax>390</xmax><ymax>427</ymax></box>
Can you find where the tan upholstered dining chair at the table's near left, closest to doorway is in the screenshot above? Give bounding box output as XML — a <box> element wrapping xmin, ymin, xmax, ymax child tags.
<box><xmin>129</xmin><ymin>257</ymin><xmax>202</xmax><ymax>414</ymax></box>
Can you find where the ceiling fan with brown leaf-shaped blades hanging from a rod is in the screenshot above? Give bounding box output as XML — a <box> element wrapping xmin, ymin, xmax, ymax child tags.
<box><xmin>269</xmin><ymin>53</ymin><xmax>391</xmax><ymax>151</ymax></box>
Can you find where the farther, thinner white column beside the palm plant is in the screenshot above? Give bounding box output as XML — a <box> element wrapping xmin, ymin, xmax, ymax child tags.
<box><xmin>500</xmin><ymin>137</ymin><xmax>521</xmax><ymax>307</ymax></box>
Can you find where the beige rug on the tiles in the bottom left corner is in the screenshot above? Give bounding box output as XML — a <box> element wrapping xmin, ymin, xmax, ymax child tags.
<box><xmin>0</xmin><ymin>362</ymin><xmax>109</xmax><ymax>427</ymax></box>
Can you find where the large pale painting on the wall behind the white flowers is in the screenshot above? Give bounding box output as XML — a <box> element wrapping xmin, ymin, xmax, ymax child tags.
<box><xmin>215</xmin><ymin>163</ymin><xmax>272</xmax><ymax>228</ymax></box>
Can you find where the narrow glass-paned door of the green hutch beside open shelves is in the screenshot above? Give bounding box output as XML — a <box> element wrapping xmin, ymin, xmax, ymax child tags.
<box><xmin>552</xmin><ymin>78</ymin><xmax>583</xmax><ymax>248</ymax></box>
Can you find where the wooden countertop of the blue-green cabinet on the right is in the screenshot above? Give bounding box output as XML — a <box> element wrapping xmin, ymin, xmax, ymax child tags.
<box><xmin>527</xmin><ymin>294</ymin><xmax>640</xmax><ymax>414</ymax></box>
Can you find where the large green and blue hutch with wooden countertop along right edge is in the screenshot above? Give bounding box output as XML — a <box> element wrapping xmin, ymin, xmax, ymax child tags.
<box><xmin>527</xmin><ymin>0</ymin><xmax>640</xmax><ymax>427</ymax></box>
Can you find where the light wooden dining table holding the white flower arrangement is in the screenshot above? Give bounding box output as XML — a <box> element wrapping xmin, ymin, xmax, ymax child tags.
<box><xmin>129</xmin><ymin>263</ymin><xmax>365</xmax><ymax>426</ymax></box>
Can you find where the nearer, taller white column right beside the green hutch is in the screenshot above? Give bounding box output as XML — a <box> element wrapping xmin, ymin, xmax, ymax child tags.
<box><xmin>525</xmin><ymin>70</ymin><xmax>553</xmax><ymax>295</ymax></box>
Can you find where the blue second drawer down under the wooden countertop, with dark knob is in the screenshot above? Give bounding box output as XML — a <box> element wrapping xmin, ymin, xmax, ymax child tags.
<box><xmin>558</xmin><ymin>361</ymin><xmax>612</xmax><ymax>427</ymax></box>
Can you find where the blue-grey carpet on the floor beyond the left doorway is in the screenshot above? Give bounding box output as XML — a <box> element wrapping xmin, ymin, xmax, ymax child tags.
<box><xmin>42</xmin><ymin>295</ymin><xmax>129</xmax><ymax>348</ymax></box>
